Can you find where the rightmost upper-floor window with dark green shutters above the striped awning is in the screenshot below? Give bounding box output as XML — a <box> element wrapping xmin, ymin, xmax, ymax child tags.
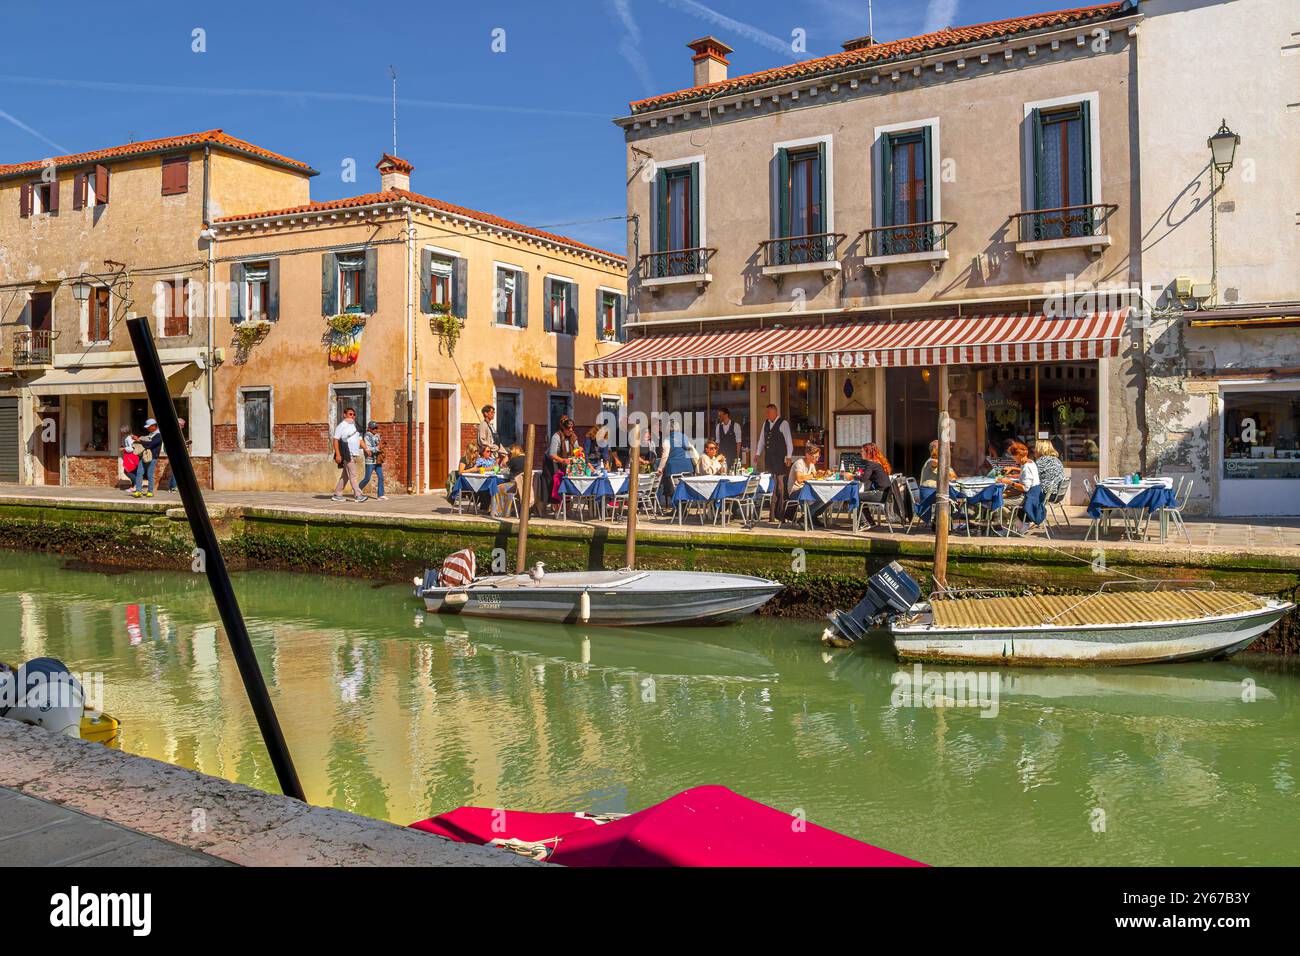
<box><xmin>1031</xmin><ymin>101</ymin><xmax>1093</xmax><ymax>239</ymax></box>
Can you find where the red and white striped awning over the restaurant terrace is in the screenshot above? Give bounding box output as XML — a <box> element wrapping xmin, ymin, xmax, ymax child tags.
<box><xmin>582</xmin><ymin>308</ymin><xmax>1128</xmax><ymax>378</ymax></box>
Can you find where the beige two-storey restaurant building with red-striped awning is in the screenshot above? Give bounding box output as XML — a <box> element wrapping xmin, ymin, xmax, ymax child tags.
<box><xmin>586</xmin><ymin>3</ymin><xmax>1141</xmax><ymax>501</ymax></box>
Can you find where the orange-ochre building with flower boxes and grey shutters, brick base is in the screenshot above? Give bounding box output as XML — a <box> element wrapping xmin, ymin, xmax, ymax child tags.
<box><xmin>213</xmin><ymin>155</ymin><xmax>627</xmax><ymax>494</ymax></box>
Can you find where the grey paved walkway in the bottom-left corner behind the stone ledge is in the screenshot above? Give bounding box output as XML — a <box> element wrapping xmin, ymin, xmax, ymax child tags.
<box><xmin>0</xmin><ymin>787</ymin><xmax>234</xmax><ymax>866</ymax></box>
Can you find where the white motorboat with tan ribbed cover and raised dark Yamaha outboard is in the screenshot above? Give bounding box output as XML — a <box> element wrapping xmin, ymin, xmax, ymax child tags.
<box><xmin>823</xmin><ymin>562</ymin><xmax>1294</xmax><ymax>665</ymax></box>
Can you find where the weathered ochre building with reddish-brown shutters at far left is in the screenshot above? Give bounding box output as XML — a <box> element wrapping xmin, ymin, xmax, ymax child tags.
<box><xmin>0</xmin><ymin>130</ymin><xmax>316</xmax><ymax>485</ymax></box>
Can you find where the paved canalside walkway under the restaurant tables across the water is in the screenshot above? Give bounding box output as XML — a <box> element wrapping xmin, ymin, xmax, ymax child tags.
<box><xmin>0</xmin><ymin>484</ymin><xmax>1300</xmax><ymax>551</ymax></box>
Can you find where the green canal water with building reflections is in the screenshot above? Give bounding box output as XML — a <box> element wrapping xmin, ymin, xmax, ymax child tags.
<box><xmin>0</xmin><ymin>551</ymin><xmax>1300</xmax><ymax>865</ymax></box>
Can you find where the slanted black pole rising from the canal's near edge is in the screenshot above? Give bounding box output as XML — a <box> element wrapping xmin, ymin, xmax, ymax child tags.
<box><xmin>126</xmin><ymin>316</ymin><xmax>307</xmax><ymax>803</ymax></box>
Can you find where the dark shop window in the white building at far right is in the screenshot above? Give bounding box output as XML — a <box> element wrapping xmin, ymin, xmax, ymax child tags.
<box><xmin>1223</xmin><ymin>392</ymin><xmax>1300</xmax><ymax>479</ymax></box>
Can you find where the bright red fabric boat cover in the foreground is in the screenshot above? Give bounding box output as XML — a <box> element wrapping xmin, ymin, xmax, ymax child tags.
<box><xmin>412</xmin><ymin>786</ymin><xmax>924</xmax><ymax>866</ymax></box>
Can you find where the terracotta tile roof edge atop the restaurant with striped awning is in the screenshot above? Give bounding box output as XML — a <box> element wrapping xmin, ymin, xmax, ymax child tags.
<box><xmin>628</xmin><ymin>0</ymin><xmax>1132</xmax><ymax>114</ymax></box>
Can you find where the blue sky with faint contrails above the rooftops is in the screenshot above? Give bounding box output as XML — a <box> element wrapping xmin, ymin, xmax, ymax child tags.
<box><xmin>0</xmin><ymin>0</ymin><xmax>1066</xmax><ymax>251</ymax></box>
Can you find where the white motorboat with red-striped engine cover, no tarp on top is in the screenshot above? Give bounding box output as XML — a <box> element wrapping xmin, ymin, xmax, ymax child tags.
<box><xmin>415</xmin><ymin>567</ymin><xmax>784</xmax><ymax>627</ymax></box>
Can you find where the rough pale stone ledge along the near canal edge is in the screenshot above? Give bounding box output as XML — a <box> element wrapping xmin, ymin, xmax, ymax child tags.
<box><xmin>0</xmin><ymin>719</ymin><xmax>533</xmax><ymax>866</ymax></box>
